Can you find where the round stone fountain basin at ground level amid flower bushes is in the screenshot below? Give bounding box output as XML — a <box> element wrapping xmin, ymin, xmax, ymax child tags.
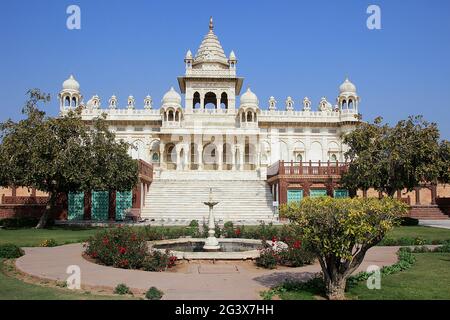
<box><xmin>149</xmin><ymin>238</ymin><xmax>262</xmax><ymax>260</ymax></box>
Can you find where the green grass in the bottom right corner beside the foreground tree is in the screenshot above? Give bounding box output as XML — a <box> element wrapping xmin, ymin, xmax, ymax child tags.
<box><xmin>347</xmin><ymin>253</ymin><xmax>450</xmax><ymax>300</ymax></box>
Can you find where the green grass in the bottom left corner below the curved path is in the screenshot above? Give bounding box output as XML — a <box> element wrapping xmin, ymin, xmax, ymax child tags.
<box><xmin>0</xmin><ymin>259</ymin><xmax>131</xmax><ymax>300</ymax></box>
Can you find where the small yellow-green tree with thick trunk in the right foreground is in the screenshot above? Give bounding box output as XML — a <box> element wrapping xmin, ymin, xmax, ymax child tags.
<box><xmin>280</xmin><ymin>197</ymin><xmax>407</xmax><ymax>300</ymax></box>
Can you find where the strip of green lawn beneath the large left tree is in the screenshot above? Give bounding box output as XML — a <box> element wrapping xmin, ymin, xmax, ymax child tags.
<box><xmin>0</xmin><ymin>227</ymin><xmax>99</xmax><ymax>247</ymax></box>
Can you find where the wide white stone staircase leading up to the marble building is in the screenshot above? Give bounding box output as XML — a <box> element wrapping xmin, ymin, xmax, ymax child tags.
<box><xmin>141</xmin><ymin>179</ymin><xmax>274</xmax><ymax>222</ymax></box>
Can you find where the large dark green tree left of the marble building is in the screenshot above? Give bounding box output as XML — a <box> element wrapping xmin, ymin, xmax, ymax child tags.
<box><xmin>0</xmin><ymin>89</ymin><xmax>138</xmax><ymax>228</ymax></box>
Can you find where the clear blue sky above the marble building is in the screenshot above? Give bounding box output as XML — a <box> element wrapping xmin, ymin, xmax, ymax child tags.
<box><xmin>0</xmin><ymin>0</ymin><xmax>450</xmax><ymax>139</ymax></box>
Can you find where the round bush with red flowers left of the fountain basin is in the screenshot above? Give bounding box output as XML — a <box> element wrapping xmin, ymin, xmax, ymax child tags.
<box><xmin>85</xmin><ymin>227</ymin><xmax>148</xmax><ymax>269</ymax></box>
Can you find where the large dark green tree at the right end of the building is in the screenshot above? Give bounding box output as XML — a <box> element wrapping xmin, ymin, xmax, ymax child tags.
<box><xmin>342</xmin><ymin>116</ymin><xmax>450</xmax><ymax>197</ymax></box>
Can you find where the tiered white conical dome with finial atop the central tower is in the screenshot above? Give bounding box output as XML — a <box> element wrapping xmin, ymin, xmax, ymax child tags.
<box><xmin>194</xmin><ymin>18</ymin><xmax>228</xmax><ymax>64</ymax></box>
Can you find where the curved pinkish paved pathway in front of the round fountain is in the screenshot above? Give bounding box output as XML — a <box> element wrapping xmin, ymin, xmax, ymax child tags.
<box><xmin>16</xmin><ymin>244</ymin><xmax>399</xmax><ymax>300</ymax></box>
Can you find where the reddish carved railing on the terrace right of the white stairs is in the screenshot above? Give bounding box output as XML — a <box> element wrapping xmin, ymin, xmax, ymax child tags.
<box><xmin>267</xmin><ymin>161</ymin><xmax>348</xmax><ymax>177</ymax></box>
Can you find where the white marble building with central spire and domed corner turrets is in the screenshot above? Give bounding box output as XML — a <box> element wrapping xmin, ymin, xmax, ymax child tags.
<box><xmin>59</xmin><ymin>19</ymin><xmax>360</xmax><ymax>219</ymax></box>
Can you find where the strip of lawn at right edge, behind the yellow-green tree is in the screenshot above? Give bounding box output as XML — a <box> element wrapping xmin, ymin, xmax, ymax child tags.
<box><xmin>386</xmin><ymin>226</ymin><xmax>450</xmax><ymax>242</ymax></box>
